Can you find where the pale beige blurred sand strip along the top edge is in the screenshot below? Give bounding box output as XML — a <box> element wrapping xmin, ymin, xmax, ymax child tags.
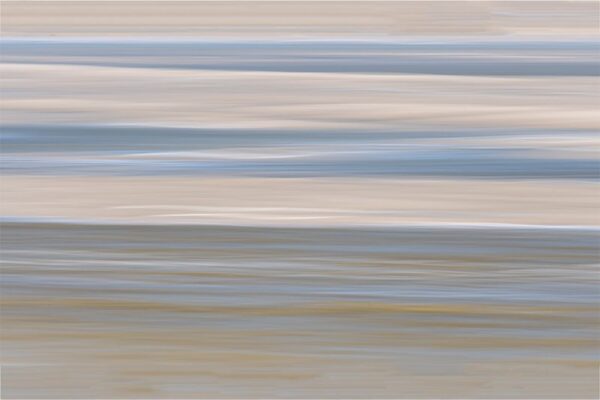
<box><xmin>2</xmin><ymin>0</ymin><xmax>598</xmax><ymax>38</ymax></box>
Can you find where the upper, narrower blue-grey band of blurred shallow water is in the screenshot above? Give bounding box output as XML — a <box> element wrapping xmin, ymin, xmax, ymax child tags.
<box><xmin>3</xmin><ymin>38</ymin><xmax>600</xmax><ymax>76</ymax></box>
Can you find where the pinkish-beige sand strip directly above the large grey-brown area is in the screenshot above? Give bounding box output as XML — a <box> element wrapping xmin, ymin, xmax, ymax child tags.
<box><xmin>0</xmin><ymin>175</ymin><xmax>600</xmax><ymax>229</ymax></box>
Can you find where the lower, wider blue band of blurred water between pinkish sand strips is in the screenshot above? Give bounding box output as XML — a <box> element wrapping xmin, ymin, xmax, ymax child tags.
<box><xmin>1</xmin><ymin>126</ymin><xmax>599</xmax><ymax>180</ymax></box>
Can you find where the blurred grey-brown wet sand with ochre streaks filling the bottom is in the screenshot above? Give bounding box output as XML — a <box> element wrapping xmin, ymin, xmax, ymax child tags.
<box><xmin>2</xmin><ymin>223</ymin><xmax>598</xmax><ymax>398</ymax></box>
